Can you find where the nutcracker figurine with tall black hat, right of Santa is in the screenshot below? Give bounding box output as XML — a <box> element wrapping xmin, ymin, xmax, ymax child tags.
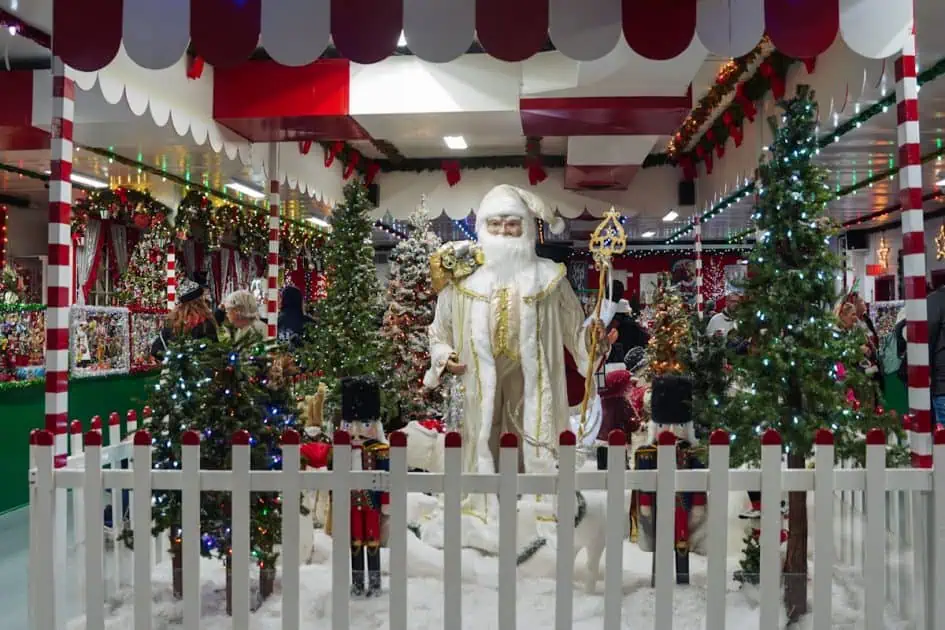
<box><xmin>634</xmin><ymin>375</ymin><xmax>706</xmax><ymax>584</ymax></box>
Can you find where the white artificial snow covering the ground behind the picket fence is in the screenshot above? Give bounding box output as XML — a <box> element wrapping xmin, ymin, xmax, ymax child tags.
<box><xmin>68</xmin><ymin>532</ymin><xmax>910</xmax><ymax>630</ymax></box>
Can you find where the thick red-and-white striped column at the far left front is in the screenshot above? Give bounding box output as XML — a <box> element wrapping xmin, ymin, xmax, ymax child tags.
<box><xmin>46</xmin><ymin>57</ymin><xmax>75</xmax><ymax>467</ymax></box>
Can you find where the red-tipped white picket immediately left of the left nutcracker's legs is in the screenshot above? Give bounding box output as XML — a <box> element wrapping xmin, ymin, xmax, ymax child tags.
<box><xmin>331</xmin><ymin>431</ymin><xmax>351</xmax><ymax>630</ymax></box>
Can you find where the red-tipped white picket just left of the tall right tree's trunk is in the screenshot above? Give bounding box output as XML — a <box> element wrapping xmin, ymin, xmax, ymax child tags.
<box><xmin>758</xmin><ymin>429</ymin><xmax>783</xmax><ymax>628</ymax></box>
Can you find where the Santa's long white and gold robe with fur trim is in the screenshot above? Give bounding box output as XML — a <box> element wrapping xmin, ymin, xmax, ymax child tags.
<box><xmin>424</xmin><ymin>258</ymin><xmax>588</xmax><ymax>472</ymax></box>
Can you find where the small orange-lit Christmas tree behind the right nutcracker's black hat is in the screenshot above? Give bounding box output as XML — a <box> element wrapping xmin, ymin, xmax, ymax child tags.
<box><xmin>646</xmin><ymin>274</ymin><xmax>690</xmax><ymax>378</ymax></box>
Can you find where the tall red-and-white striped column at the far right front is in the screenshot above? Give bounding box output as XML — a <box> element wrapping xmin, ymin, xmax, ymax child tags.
<box><xmin>896</xmin><ymin>26</ymin><xmax>933</xmax><ymax>468</ymax></box>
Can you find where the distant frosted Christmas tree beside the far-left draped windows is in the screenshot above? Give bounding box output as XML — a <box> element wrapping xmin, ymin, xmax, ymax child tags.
<box><xmin>115</xmin><ymin>230</ymin><xmax>181</xmax><ymax>309</ymax></box>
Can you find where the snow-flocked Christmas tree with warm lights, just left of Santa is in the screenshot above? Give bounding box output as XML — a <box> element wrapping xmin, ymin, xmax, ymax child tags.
<box><xmin>381</xmin><ymin>202</ymin><xmax>442</xmax><ymax>421</ymax></box>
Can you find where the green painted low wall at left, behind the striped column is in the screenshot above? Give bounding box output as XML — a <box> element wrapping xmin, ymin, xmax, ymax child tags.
<box><xmin>0</xmin><ymin>374</ymin><xmax>156</xmax><ymax>514</ymax></box>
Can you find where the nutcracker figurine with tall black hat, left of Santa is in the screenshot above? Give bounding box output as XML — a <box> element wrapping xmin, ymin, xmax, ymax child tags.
<box><xmin>341</xmin><ymin>377</ymin><xmax>390</xmax><ymax>597</ymax></box>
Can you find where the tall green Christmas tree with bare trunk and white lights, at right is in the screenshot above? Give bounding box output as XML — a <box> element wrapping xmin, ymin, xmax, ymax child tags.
<box><xmin>723</xmin><ymin>86</ymin><xmax>897</xmax><ymax>621</ymax></box>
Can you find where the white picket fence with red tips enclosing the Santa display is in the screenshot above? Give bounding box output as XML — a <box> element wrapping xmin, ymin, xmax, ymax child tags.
<box><xmin>29</xmin><ymin>414</ymin><xmax>945</xmax><ymax>630</ymax></box>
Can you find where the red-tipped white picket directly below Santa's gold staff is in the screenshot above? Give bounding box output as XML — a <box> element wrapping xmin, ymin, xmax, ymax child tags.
<box><xmin>555</xmin><ymin>431</ymin><xmax>577</xmax><ymax>630</ymax></box>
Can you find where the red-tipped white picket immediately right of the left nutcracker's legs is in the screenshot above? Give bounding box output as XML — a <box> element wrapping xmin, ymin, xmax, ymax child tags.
<box><xmin>387</xmin><ymin>431</ymin><xmax>410</xmax><ymax>630</ymax></box>
